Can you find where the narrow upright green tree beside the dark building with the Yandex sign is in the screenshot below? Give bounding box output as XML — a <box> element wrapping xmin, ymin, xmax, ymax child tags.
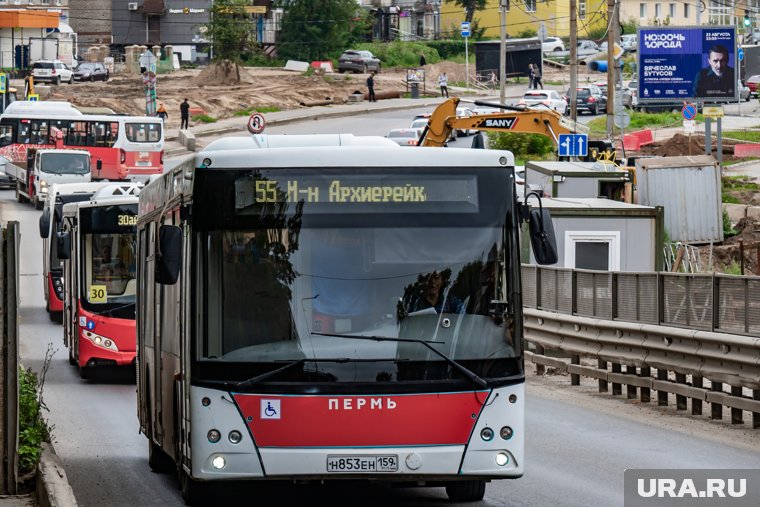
<box><xmin>206</xmin><ymin>0</ymin><xmax>252</xmax><ymax>63</ymax></box>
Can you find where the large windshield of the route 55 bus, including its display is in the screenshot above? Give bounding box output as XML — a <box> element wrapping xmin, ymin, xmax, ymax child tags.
<box><xmin>195</xmin><ymin>169</ymin><xmax>522</xmax><ymax>382</ymax></box>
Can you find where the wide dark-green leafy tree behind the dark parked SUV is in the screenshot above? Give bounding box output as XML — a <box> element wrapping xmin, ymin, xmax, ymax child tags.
<box><xmin>277</xmin><ymin>0</ymin><xmax>368</xmax><ymax>60</ymax></box>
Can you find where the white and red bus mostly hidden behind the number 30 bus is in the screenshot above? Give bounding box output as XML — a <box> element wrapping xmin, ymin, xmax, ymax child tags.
<box><xmin>39</xmin><ymin>182</ymin><xmax>139</xmax><ymax>323</ymax></box>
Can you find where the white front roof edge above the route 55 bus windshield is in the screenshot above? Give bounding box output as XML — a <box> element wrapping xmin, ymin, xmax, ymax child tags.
<box><xmin>195</xmin><ymin>145</ymin><xmax>515</xmax><ymax>169</ymax></box>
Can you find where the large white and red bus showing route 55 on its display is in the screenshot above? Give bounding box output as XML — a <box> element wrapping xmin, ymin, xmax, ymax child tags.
<box><xmin>137</xmin><ymin>136</ymin><xmax>556</xmax><ymax>504</ymax></box>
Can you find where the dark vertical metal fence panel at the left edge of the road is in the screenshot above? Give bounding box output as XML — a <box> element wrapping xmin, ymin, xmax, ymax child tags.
<box><xmin>0</xmin><ymin>222</ymin><xmax>20</xmax><ymax>495</ymax></box>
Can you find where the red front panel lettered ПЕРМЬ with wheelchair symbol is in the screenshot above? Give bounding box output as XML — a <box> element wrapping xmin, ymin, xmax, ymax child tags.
<box><xmin>234</xmin><ymin>392</ymin><xmax>488</xmax><ymax>447</ymax></box>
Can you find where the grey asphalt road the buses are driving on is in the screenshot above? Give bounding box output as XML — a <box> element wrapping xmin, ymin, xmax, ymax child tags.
<box><xmin>0</xmin><ymin>111</ymin><xmax>760</xmax><ymax>507</ymax></box>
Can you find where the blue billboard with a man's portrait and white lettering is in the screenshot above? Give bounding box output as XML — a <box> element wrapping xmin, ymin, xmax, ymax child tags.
<box><xmin>638</xmin><ymin>26</ymin><xmax>739</xmax><ymax>103</ymax></box>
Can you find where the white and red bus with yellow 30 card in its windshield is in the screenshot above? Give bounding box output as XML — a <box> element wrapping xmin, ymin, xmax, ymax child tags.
<box><xmin>57</xmin><ymin>184</ymin><xmax>140</xmax><ymax>379</ymax></box>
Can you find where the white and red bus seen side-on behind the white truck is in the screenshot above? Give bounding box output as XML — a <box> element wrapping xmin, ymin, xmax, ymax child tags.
<box><xmin>0</xmin><ymin>101</ymin><xmax>164</xmax><ymax>181</ymax></box>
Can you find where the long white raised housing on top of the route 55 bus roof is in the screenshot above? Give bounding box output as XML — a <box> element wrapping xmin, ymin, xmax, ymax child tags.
<box><xmin>203</xmin><ymin>134</ymin><xmax>399</xmax><ymax>152</ymax></box>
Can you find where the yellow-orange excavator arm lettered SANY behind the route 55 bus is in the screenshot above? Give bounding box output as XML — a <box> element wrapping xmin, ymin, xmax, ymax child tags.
<box><xmin>419</xmin><ymin>97</ymin><xmax>588</xmax><ymax>146</ymax></box>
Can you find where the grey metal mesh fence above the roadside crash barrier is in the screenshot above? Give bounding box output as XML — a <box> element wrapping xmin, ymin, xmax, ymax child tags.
<box><xmin>522</xmin><ymin>265</ymin><xmax>760</xmax><ymax>336</ymax></box>
